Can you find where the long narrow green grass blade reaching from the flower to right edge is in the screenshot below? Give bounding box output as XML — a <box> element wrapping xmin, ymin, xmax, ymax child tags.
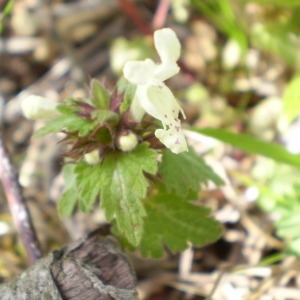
<box><xmin>189</xmin><ymin>127</ymin><xmax>300</xmax><ymax>168</ymax></box>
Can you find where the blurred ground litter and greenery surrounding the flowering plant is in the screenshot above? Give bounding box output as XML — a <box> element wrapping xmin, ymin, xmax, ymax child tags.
<box><xmin>0</xmin><ymin>0</ymin><xmax>300</xmax><ymax>299</ymax></box>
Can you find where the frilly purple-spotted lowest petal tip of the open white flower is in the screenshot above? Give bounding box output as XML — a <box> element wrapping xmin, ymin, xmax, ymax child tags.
<box><xmin>155</xmin><ymin>128</ymin><xmax>188</xmax><ymax>154</ymax></box>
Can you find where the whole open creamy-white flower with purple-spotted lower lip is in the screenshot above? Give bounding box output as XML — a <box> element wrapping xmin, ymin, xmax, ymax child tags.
<box><xmin>123</xmin><ymin>28</ymin><xmax>188</xmax><ymax>153</ymax></box>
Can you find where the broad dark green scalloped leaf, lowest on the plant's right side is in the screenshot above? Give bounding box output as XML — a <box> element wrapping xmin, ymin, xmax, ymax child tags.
<box><xmin>140</xmin><ymin>193</ymin><xmax>222</xmax><ymax>258</ymax></box>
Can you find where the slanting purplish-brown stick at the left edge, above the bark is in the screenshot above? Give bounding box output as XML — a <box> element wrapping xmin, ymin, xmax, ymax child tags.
<box><xmin>0</xmin><ymin>134</ymin><xmax>42</xmax><ymax>264</ymax></box>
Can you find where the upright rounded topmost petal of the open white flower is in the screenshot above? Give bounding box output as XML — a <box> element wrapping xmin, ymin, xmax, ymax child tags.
<box><xmin>154</xmin><ymin>28</ymin><xmax>181</xmax><ymax>64</ymax></box>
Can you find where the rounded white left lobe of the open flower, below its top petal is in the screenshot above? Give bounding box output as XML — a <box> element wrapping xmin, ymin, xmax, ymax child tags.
<box><xmin>123</xmin><ymin>59</ymin><xmax>156</xmax><ymax>85</ymax></box>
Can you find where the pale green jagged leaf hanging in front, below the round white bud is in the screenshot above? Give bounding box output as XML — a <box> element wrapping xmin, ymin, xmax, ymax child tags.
<box><xmin>99</xmin><ymin>143</ymin><xmax>157</xmax><ymax>246</ymax></box>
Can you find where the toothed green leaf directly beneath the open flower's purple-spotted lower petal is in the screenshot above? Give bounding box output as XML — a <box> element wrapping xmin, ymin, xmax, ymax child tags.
<box><xmin>159</xmin><ymin>148</ymin><xmax>223</xmax><ymax>197</ymax></box>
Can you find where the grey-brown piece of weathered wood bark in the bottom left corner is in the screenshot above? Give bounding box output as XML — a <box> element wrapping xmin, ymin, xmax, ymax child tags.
<box><xmin>0</xmin><ymin>231</ymin><xmax>138</xmax><ymax>300</ymax></box>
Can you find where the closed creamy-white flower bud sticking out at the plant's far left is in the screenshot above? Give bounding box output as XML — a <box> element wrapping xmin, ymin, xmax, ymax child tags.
<box><xmin>21</xmin><ymin>95</ymin><xmax>58</xmax><ymax>120</ymax></box>
